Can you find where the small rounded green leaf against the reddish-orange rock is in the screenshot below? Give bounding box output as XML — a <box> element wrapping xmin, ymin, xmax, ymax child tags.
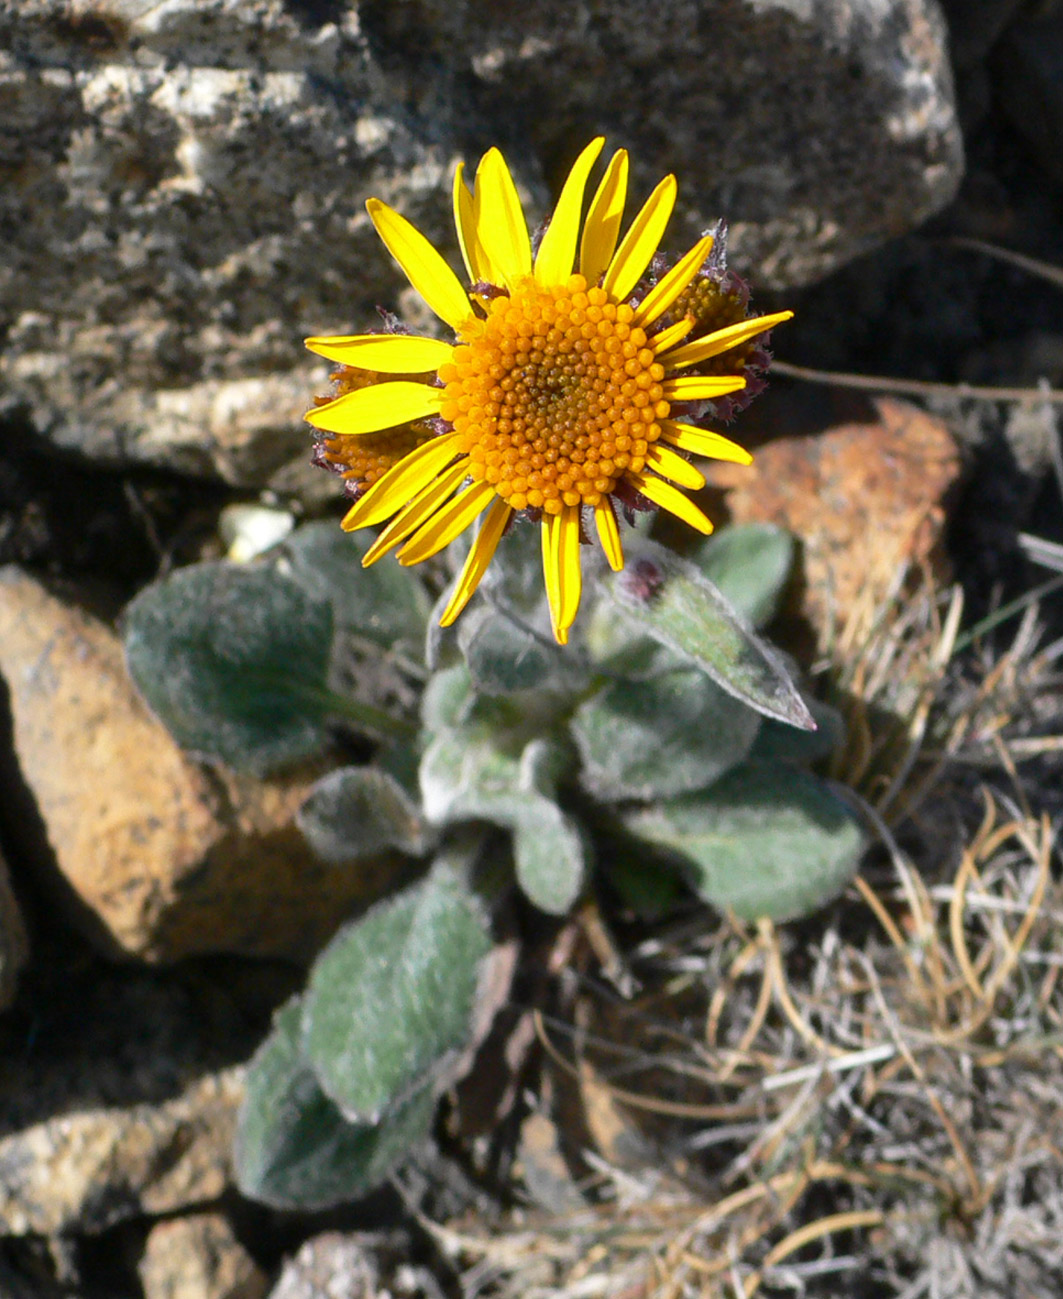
<box><xmin>690</xmin><ymin>523</ymin><xmax>794</xmax><ymax>627</ymax></box>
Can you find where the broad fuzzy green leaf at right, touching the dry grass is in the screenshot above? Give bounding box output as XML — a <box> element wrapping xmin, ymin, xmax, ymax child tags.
<box><xmin>624</xmin><ymin>763</ymin><xmax>864</xmax><ymax>920</ymax></box>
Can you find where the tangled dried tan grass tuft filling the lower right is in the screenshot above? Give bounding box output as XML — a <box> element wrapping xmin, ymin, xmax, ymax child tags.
<box><xmin>431</xmin><ymin>563</ymin><xmax>1063</xmax><ymax>1299</ymax></box>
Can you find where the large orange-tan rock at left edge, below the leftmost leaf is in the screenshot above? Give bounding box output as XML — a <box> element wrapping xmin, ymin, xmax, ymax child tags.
<box><xmin>0</xmin><ymin>568</ymin><xmax>398</xmax><ymax>961</ymax></box>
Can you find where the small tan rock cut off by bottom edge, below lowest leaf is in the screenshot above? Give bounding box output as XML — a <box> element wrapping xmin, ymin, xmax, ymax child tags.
<box><xmin>136</xmin><ymin>1213</ymin><xmax>269</xmax><ymax>1299</ymax></box>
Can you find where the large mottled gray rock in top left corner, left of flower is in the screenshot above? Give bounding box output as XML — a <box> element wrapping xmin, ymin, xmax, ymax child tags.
<box><xmin>0</xmin><ymin>0</ymin><xmax>454</xmax><ymax>485</ymax></box>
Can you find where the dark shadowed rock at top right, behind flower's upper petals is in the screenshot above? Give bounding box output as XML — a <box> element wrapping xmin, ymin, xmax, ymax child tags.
<box><xmin>386</xmin><ymin>0</ymin><xmax>963</xmax><ymax>288</ymax></box>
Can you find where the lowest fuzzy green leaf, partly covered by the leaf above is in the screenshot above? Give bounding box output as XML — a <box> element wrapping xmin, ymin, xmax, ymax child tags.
<box><xmin>234</xmin><ymin>999</ymin><xmax>435</xmax><ymax>1209</ymax></box>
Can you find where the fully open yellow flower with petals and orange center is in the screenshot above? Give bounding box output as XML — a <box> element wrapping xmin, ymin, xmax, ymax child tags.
<box><xmin>307</xmin><ymin>139</ymin><xmax>793</xmax><ymax>644</ymax></box>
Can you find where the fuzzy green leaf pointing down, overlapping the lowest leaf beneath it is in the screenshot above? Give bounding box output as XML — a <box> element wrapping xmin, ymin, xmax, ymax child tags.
<box><xmin>303</xmin><ymin>857</ymin><xmax>491</xmax><ymax>1124</ymax></box>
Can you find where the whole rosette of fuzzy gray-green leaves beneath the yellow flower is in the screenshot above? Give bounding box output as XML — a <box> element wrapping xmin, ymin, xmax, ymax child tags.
<box><xmin>201</xmin><ymin>511</ymin><xmax>863</xmax><ymax>1208</ymax></box>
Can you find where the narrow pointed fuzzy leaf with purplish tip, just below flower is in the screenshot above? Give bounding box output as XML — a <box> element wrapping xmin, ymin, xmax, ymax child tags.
<box><xmin>603</xmin><ymin>535</ymin><xmax>816</xmax><ymax>730</ymax></box>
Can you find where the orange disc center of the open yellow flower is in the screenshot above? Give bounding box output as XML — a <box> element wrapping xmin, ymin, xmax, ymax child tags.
<box><xmin>439</xmin><ymin>275</ymin><xmax>669</xmax><ymax>514</ymax></box>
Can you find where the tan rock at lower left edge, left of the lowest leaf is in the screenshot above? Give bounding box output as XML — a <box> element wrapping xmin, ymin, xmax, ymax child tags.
<box><xmin>0</xmin><ymin>1069</ymin><xmax>243</xmax><ymax>1235</ymax></box>
